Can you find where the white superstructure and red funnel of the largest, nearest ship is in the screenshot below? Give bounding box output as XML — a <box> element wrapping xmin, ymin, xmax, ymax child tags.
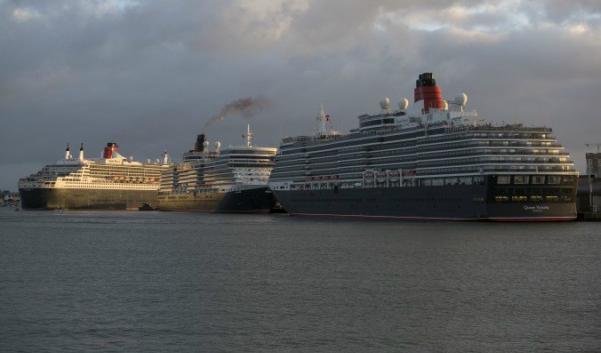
<box><xmin>270</xmin><ymin>73</ymin><xmax>577</xmax><ymax>190</ymax></box>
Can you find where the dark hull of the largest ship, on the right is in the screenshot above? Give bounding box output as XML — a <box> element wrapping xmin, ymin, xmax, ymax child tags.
<box><xmin>274</xmin><ymin>185</ymin><xmax>576</xmax><ymax>221</ymax></box>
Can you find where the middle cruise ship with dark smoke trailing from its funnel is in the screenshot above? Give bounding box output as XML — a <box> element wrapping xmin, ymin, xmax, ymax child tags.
<box><xmin>158</xmin><ymin>125</ymin><xmax>277</xmax><ymax>213</ymax></box>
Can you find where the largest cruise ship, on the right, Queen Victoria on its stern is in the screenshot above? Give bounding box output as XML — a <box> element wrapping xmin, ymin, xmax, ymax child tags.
<box><xmin>270</xmin><ymin>73</ymin><xmax>578</xmax><ymax>221</ymax></box>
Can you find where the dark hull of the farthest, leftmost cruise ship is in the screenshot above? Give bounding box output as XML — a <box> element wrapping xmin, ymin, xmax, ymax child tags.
<box><xmin>19</xmin><ymin>189</ymin><xmax>157</xmax><ymax>210</ymax></box>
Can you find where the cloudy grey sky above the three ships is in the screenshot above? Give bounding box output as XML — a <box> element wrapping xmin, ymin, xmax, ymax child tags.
<box><xmin>0</xmin><ymin>0</ymin><xmax>601</xmax><ymax>190</ymax></box>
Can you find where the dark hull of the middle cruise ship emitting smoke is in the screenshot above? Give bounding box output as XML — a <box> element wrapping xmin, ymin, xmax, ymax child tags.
<box><xmin>158</xmin><ymin>187</ymin><xmax>275</xmax><ymax>213</ymax></box>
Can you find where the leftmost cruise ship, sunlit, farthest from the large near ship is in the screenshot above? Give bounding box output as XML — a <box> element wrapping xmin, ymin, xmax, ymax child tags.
<box><xmin>19</xmin><ymin>142</ymin><xmax>169</xmax><ymax>210</ymax></box>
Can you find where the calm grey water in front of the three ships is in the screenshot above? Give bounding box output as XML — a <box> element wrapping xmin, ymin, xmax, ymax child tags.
<box><xmin>0</xmin><ymin>209</ymin><xmax>601</xmax><ymax>352</ymax></box>
